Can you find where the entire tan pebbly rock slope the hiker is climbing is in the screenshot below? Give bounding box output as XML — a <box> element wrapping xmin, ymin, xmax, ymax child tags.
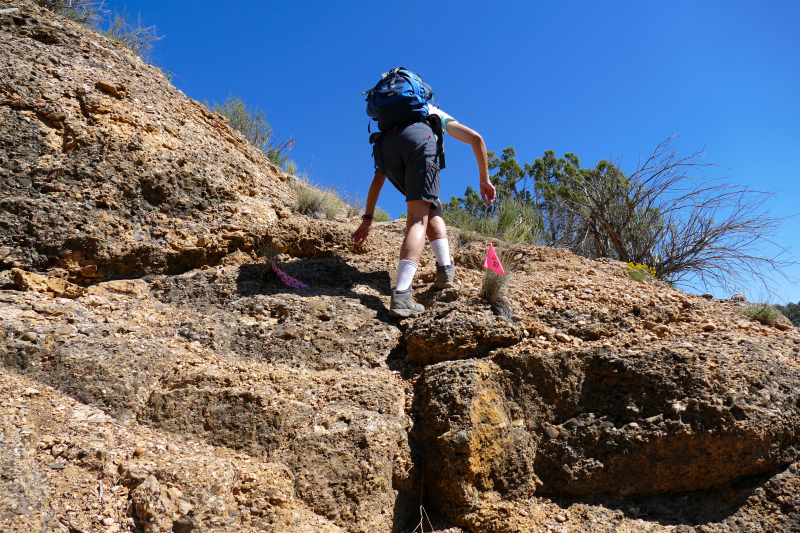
<box><xmin>0</xmin><ymin>0</ymin><xmax>800</xmax><ymax>533</ymax></box>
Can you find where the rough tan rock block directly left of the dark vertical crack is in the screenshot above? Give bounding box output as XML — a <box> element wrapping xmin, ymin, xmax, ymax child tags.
<box><xmin>142</xmin><ymin>369</ymin><xmax>407</xmax><ymax>532</ymax></box>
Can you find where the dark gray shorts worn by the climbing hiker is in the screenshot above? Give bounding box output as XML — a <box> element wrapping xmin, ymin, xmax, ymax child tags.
<box><xmin>380</xmin><ymin>122</ymin><xmax>439</xmax><ymax>206</ymax></box>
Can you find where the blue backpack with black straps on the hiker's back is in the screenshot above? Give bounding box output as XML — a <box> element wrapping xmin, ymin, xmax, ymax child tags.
<box><xmin>361</xmin><ymin>67</ymin><xmax>445</xmax><ymax>172</ymax></box>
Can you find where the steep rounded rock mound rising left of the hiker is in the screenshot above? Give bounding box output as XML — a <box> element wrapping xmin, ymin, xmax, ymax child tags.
<box><xmin>0</xmin><ymin>1</ymin><xmax>288</xmax><ymax>281</ymax></box>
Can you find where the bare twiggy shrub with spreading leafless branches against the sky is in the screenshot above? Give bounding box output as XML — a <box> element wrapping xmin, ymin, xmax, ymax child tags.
<box><xmin>555</xmin><ymin>136</ymin><xmax>794</xmax><ymax>296</ymax></box>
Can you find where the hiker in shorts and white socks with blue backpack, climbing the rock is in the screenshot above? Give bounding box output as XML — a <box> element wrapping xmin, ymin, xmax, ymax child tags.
<box><xmin>353</xmin><ymin>67</ymin><xmax>496</xmax><ymax>317</ymax></box>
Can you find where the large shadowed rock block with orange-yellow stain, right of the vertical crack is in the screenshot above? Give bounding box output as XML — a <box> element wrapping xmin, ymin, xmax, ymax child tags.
<box><xmin>421</xmin><ymin>338</ymin><xmax>800</xmax><ymax>517</ymax></box>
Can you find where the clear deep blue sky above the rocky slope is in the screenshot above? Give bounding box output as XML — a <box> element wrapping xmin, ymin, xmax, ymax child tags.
<box><xmin>100</xmin><ymin>0</ymin><xmax>800</xmax><ymax>303</ymax></box>
